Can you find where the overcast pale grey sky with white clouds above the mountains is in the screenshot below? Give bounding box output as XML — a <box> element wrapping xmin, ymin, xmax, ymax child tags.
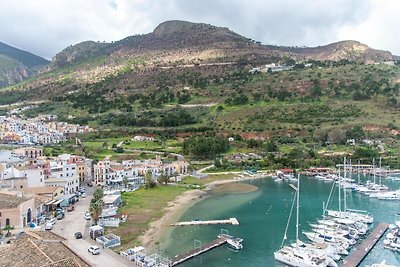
<box><xmin>0</xmin><ymin>0</ymin><xmax>400</xmax><ymax>59</ymax></box>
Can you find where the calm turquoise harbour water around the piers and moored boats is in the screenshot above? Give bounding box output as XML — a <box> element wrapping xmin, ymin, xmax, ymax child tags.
<box><xmin>161</xmin><ymin>177</ymin><xmax>400</xmax><ymax>267</ymax></box>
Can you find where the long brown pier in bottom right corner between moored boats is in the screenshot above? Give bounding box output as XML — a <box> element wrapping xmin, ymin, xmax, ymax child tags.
<box><xmin>341</xmin><ymin>223</ymin><xmax>389</xmax><ymax>267</ymax></box>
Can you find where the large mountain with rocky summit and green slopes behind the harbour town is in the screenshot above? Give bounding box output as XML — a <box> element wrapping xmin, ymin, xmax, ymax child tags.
<box><xmin>0</xmin><ymin>21</ymin><xmax>400</xmax><ymax>142</ymax></box>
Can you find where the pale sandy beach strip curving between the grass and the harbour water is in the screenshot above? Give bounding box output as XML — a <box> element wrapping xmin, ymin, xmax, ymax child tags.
<box><xmin>139</xmin><ymin>173</ymin><xmax>270</xmax><ymax>251</ymax></box>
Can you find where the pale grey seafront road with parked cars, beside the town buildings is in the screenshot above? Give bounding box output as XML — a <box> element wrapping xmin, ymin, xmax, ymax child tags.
<box><xmin>52</xmin><ymin>187</ymin><xmax>136</xmax><ymax>267</ymax></box>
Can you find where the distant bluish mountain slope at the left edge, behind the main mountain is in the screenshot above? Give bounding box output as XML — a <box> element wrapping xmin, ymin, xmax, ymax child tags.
<box><xmin>0</xmin><ymin>42</ymin><xmax>49</xmax><ymax>87</ymax></box>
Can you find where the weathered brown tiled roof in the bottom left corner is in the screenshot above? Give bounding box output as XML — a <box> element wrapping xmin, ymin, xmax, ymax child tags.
<box><xmin>0</xmin><ymin>231</ymin><xmax>90</xmax><ymax>267</ymax></box>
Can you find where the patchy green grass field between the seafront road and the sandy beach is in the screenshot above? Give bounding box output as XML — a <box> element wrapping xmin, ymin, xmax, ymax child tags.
<box><xmin>108</xmin><ymin>185</ymin><xmax>186</xmax><ymax>250</ymax></box>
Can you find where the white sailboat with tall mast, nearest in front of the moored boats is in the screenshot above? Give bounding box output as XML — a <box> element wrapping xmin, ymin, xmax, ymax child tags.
<box><xmin>274</xmin><ymin>176</ymin><xmax>338</xmax><ymax>267</ymax></box>
